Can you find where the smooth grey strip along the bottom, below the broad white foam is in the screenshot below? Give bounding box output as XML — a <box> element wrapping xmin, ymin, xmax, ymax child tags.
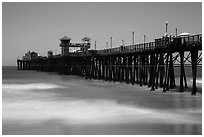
<box><xmin>3</xmin><ymin>119</ymin><xmax>202</xmax><ymax>135</ymax></box>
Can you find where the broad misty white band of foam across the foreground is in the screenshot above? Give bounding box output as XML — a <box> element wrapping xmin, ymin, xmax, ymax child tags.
<box><xmin>3</xmin><ymin>98</ymin><xmax>202</xmax><ymax>124</ymax></box>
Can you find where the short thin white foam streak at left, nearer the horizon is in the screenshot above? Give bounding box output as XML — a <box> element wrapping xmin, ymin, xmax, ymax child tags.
<box><xmin>2</xmin><ymin>83</ymin><xmax>59</xmax><ymax>90</ymax></box>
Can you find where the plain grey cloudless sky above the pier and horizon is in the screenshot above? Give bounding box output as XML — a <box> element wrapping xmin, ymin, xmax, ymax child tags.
<box><xmin>2</xmin><ymin>2</ymin><xmax>202</xmax><ymax>66</ymax></box>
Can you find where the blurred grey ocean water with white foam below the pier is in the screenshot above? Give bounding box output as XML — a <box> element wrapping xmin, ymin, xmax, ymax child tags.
<box><xmin>2</xmin><ymin>67</ymin><xmax>202</xmax><ymax>135</ymax></box>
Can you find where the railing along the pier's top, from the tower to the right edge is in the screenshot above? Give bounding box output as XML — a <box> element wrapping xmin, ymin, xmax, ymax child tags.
<box><xmin>96</xmin><ymin>34</ymin><xmax>202</xmax><ymax>54</ymax></box>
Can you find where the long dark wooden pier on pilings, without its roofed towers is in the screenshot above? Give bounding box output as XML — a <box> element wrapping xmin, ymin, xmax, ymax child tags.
<box><xmin>17</xmin><ymin>34</ymin><xmax>202</xmax><ymax>95</ymax></box>
